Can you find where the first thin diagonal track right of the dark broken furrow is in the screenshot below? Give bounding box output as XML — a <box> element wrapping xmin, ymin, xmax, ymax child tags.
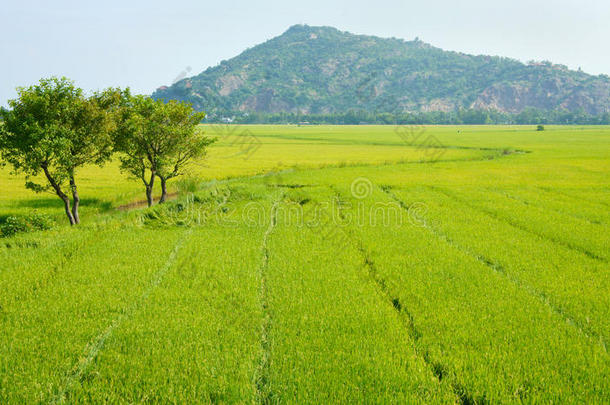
<box><xmin>381</xmin><ymin>187</ymin><xmax>607</xmax><ymax>352</ymax></box>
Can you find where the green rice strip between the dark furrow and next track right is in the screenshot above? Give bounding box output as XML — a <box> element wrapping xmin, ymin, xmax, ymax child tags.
<box><xmin>330</xmin><ymin>181</ymin><xmax>608</xmax><ymax>402</ymax></box>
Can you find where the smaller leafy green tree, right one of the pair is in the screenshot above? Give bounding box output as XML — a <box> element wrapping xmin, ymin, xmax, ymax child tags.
<box><xmin>115</xmin><ymin>96</ymin><xmax>213</xmax><ymax>207</ymax></box>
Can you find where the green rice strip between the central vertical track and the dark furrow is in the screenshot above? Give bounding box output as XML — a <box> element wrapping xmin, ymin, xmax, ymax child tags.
<box><xmin>267</xmin><ymin>189</ymin><xmax>456</xmax><ymax>403</ymax></box>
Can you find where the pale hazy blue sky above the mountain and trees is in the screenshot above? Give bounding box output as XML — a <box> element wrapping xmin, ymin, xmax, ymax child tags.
<box><xmin>0</xmin><ymin>0</ymin><xmax>610</xmax><ymax>105</ymax></box>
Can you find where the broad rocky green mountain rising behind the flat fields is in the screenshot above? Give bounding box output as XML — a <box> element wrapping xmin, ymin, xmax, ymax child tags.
<box><xmin>152</xmin><ymin>25</ymin><xmax>610</xmax><ymax>116</ymax></box>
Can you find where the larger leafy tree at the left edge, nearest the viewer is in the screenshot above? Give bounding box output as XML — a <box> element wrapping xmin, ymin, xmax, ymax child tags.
<box><xmin>0</xmin><ymin>77</ymin><xmax>113</xmax><ymax>225</ymax></box>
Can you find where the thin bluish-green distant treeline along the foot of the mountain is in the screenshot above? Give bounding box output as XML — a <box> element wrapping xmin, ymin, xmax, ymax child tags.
<box><xmin>207</xmin><ymin>109</ymin><xmax>610</xmax><ymax>125</ymax></box>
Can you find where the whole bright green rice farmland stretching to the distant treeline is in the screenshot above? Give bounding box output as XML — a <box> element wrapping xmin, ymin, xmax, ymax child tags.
<box><xmin>0</xmin><ymin>125</ymin><xmax>610</xmax><ymax>403</ymax></box>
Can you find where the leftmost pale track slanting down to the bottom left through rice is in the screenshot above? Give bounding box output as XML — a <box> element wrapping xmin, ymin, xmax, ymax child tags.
<box><xmin>50</xmin><ymin>229</ymin><xmax>192</xmax><ymax>404</ymax></box>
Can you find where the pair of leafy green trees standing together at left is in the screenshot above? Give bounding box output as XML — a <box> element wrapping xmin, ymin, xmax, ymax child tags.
<box><xmin>0</xmin><ymin>77</ymin><xmax>214</xmax><ymax>225</ymax></box>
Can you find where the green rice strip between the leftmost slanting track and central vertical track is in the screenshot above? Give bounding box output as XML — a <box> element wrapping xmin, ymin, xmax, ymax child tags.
<box><xmin>62</xmin><ymin>197</ymin><xmax>271</xmax><ymax>403</ymax></box>
